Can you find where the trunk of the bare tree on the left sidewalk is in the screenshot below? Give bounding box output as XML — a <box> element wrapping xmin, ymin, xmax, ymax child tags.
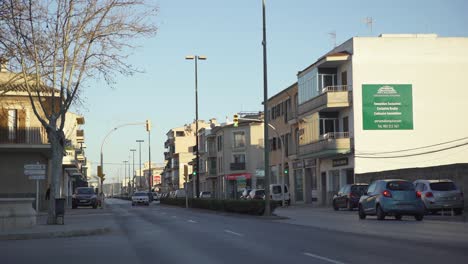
<box><xmin>47</xmin><ymin>122</ymin><xmax>65</xmax><ymax>225</ymax></box>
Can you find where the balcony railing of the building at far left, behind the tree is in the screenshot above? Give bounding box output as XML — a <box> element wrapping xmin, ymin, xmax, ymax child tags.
<box><xmin>0</xmin><ymin>127</ymin><xmax>49</xmax><ymax>144</ymax></box>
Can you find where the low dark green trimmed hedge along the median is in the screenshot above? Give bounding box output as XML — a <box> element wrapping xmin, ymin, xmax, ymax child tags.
<box><xmin>160</xmin><ymin>198</ymin><xmax>278</xmax><ymax>215</ymax></box>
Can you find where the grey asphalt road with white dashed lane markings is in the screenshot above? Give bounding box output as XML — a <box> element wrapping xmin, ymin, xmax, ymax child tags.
<box><xmin>0</xmin><ymin>199</ymin><xmax>468</xmax><ymax>264</ymax></box>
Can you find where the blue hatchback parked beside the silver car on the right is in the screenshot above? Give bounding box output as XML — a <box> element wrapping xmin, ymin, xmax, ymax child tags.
<box><xmin>358</xmin><ymin>179</ymin><xmax>424</xmax><ymax>221</ymax></box>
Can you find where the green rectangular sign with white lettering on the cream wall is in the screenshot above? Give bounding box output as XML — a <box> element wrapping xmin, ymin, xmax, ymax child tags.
<box><xmin>362</xmin><ymin>84</ymin><xmax>413</xmax><ymax>130</ymax></box>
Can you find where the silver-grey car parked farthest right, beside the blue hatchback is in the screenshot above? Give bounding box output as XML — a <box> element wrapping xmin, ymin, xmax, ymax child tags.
<box><xmin>413</xmin><ymin>180</ymin><xmax>465</xmax><ymax>215</ymax></box>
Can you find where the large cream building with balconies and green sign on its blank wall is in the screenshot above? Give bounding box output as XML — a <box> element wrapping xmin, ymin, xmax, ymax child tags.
<box><xmin>293</xmin><ymin>34</ymin><xmax>468</xmax><ymax>204</ymax></box>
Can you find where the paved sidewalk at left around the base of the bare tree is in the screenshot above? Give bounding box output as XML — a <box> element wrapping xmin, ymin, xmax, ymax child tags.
<box><xmin>0</xmin><ymin>207</ymin><xmax>115</xmax><ymax>240</ymax></box>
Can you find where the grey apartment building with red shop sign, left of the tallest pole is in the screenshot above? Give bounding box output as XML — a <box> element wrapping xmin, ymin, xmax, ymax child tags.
<box><xmin>212</xmin><ymin>113</ymin><xmax>265</xmax><ymax>199</ymax></box>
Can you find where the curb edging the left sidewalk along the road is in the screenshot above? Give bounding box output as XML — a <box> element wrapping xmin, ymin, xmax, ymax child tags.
<box><xmin>0</xmin><ymin>227</ymin><xmax>112</xmax><ymax>240</ymax></box>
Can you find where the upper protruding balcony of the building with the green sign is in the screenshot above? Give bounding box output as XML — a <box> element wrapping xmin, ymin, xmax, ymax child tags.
<box><xmin>299</xmin><ymin>85</ymin><xmax>352</xmax><ymax>114</ymax></box>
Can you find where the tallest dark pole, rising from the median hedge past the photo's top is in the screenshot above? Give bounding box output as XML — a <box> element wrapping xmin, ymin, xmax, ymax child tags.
<box><xmin>262</xmin><ymin>0</ymin><xmax>271</xmax><ymax>216</ymax></box>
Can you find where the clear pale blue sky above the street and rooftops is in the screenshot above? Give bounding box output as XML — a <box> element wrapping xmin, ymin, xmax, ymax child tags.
<box><xmin>76</xmin><ymin>0</ymin><xmax>468</xmax><ymax>182</ymax></box>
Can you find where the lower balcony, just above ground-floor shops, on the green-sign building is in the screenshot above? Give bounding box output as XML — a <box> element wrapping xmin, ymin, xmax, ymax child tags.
<box><xmin>298</xmin><ymin>132</ymin><xmax>351</xmax><ymax>157</ymax></box>
